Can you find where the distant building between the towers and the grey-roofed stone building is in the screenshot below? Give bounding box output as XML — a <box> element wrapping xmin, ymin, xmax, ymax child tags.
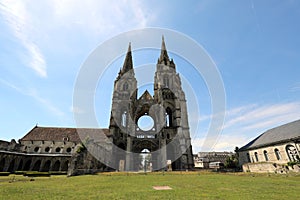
<box><xmin>194</xmin><ymin>151</ymin><xmax>234</xmax><ymax>169</ymax></box>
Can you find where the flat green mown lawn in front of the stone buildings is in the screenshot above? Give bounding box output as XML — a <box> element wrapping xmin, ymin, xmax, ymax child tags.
<box><xmin>0</xmin><ymin>172</ymin><xmax>300</xmax><ymax>200</ymax></box>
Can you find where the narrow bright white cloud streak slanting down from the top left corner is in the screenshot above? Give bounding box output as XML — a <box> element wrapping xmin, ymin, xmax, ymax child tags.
<box><xmin>0</xmin><ymin>1</ymin><xmax>47</xmax><ymax>77</ymax></box>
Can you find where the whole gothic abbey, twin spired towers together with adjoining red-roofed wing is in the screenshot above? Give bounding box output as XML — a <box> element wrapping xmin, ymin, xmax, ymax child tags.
<box><xmin>0</xmin><ymin>37</ymin><xmax>194</xmax><ymax>175</ymax></box>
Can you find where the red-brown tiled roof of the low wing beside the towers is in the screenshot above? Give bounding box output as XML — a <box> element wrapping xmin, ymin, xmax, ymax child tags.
<box><xmin>20</xmin><ymin>126</ymin><xmax>109</xmax><ymax>142</ymax></box>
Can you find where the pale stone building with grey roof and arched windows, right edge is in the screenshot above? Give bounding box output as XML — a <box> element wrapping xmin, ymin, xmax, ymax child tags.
<box><xmin>238</xmin><ymin>120</ymin><xmax>300</xmax><ymax>173</ymax></box>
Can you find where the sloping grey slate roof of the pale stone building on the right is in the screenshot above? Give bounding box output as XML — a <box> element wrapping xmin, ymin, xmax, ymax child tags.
<box><xmin>239</xmin><ymin>120</ymin><xmax>300</xmax><ymax>151</ymax></box>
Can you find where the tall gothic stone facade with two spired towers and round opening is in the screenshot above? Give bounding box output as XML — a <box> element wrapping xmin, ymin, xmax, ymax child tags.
<box><xmin>109</xmin><ymin>38</ymin><xmax>194</xmax><ymax>171</ymax></box>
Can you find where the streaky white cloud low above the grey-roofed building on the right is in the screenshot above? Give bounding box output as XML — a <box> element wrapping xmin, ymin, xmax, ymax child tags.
<box><xmin>192</xmin><ymin>102</ymin><xmax>300</xmax><ymax>152</ymax></box>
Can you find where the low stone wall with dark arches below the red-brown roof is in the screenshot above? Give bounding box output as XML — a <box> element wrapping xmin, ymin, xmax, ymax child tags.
<box><xmin>0</xmin><ymin>140</ymin><xmax>77</xmax><ymax>172</ymax></box>
